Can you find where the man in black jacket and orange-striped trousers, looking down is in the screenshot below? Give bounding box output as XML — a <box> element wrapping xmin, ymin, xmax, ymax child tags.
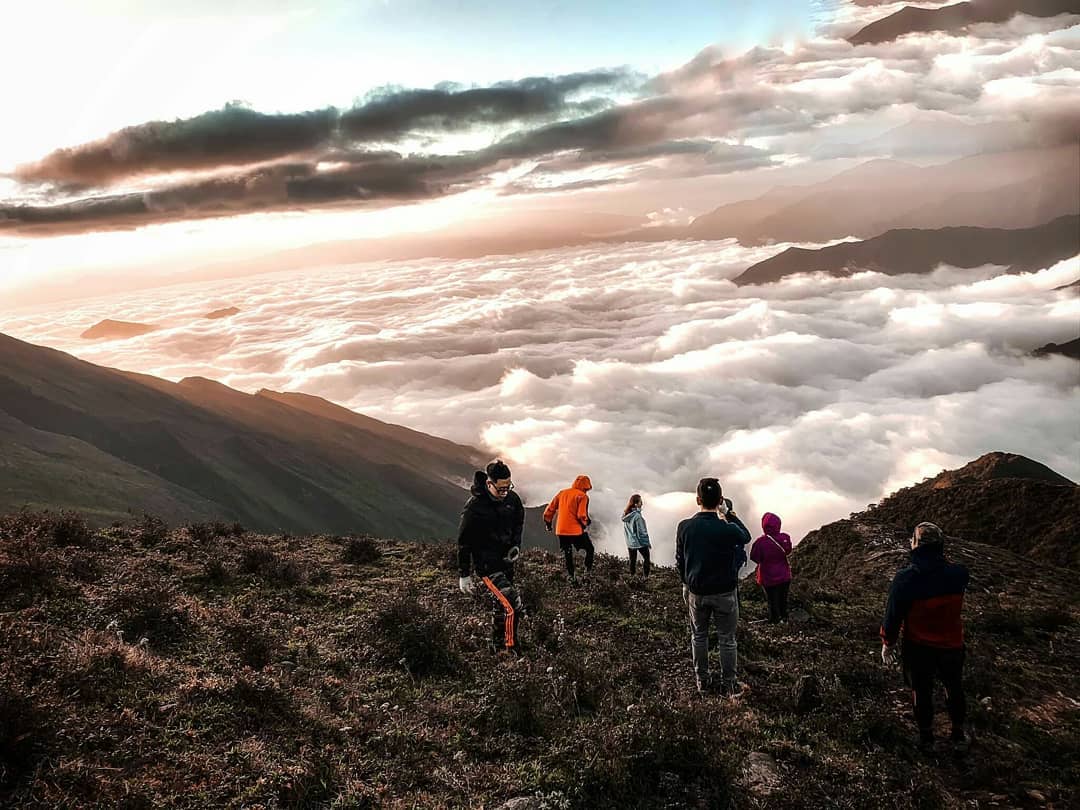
<box><xmin>458</xmin><ymin>460</ymin><xmax>525</xmax><ymax>652</ymax></box>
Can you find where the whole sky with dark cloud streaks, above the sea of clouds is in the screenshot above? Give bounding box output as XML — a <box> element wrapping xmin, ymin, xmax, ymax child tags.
<box><xmin>0</xmin><ymin>0</ymin><xmax>1080</xmax><ymax>303</ymax></box>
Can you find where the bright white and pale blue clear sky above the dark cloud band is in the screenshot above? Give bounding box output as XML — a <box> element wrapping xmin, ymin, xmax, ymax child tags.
<box><xmin>0</xmin><ymin>0</ymin><xmax>812</xmax><ymax>166</ymax></box>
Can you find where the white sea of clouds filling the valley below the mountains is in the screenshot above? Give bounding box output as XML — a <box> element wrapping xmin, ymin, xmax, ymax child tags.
<box><xmin>0</xmin><ymin>242</ymin><xmax>1080</xmax><ymax>563</ymax></box>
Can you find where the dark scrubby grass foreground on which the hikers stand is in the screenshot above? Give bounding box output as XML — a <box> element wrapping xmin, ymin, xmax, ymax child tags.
<box><xmin>0</xmin><ymin>514</ymin><xmax>1080</xmax><ymax>810</ymax></box>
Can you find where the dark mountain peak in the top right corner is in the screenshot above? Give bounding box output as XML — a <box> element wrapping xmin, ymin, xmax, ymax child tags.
<box><xmin>848</xmin><ymin>0</ymin><xmax>1080</xmax><ymax>45</ymax></box>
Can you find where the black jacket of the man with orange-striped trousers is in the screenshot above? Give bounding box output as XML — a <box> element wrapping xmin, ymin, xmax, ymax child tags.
<box><xmin>458</xmin><ymin>475</ymin><xmax>525</xmax><ymax>577</ymax></box>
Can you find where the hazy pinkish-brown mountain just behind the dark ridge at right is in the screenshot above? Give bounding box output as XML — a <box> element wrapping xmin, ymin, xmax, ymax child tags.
<box><xmin>683</xmin><ymin>147</ymin><xmax>1080</xmax><ymax>244</ymax></box>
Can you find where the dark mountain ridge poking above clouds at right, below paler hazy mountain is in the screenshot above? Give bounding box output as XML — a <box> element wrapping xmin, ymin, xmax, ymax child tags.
<box><xmin>734</xmin><ymin>216</ymin><xmax>1080</xmax><ymax>285</ymax></box>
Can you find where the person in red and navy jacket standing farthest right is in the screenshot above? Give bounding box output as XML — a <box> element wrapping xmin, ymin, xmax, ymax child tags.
<box><xmin>881</xmin><ymin>523</ymin><xmax>969</xmax><ymax>754</ymax></box>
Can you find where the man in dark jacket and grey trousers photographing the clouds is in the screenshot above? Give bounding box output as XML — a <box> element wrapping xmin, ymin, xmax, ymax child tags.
<box><xmin>675</xmin><ymin>478</ymin><xmax>751</xmax><ymax>697</ymax></box>
